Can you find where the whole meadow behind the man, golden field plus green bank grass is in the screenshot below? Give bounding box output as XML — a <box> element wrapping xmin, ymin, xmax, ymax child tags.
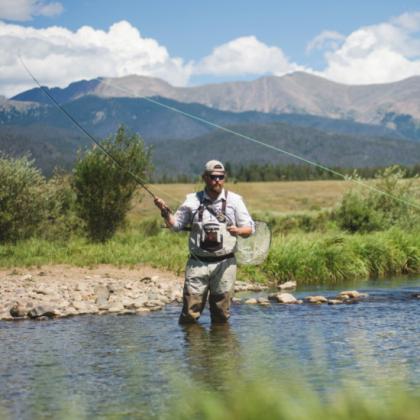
<box><xmin>0</xmin><ymin>180</ymin><xmax>420</xmax><ymax>284</ymax></box>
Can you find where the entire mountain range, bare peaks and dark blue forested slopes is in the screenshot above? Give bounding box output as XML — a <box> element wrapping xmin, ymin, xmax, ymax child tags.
<box><xmin>0</xmin><ymin>72</ymin><xmax>420</xmax><ymax>173</ymax></box>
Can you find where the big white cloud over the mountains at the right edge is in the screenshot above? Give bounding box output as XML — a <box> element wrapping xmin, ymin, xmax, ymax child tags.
<box><xmin>310</xmin><ymin>13</ymin><xmax>420</xmax><ymax>84</ymax></box>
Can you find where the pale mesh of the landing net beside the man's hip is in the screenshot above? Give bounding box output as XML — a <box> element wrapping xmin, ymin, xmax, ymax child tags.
<box><xmin>235</xmin><ymin>221</ymin><xmax>271</xmax><ymax>265</ymax></box>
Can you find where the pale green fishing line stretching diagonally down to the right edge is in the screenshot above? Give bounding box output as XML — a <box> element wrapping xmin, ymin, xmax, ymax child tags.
<box><xmin>100</xmin><ymin>78</ymin><xmax>420</xmax><ymax>210</ymax></box>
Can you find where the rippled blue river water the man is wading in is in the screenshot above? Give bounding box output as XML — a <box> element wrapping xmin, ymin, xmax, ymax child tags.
<box><xmin>0</xmin><ymin>278</ymin><xmax>420</xmax><ymax>419</ymax></box>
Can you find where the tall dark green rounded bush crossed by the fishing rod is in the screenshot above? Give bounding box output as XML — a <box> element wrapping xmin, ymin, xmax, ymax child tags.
<box><xmin>73</xmin><ymin>127</ymin><xmax>150</xmax><ymax>242</ymax></box>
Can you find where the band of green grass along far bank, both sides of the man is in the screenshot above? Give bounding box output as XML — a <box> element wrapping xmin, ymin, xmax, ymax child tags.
<box><xmin>0</xmin><ymin>218</ymin><xmax>420</xmax><ymax>284</ymax></box>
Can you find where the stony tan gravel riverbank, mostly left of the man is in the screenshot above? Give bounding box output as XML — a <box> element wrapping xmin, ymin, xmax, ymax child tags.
<box><xmin>0</xmin><ymin>265</ymin><xmax>270</xmax><ymax>320</ymax></box>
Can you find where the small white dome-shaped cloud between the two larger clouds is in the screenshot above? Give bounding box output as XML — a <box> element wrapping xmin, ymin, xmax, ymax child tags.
<box><xmin>194</xmin><ymin>36</ymin><xmax>300</xmax><ymax>76</ymax></box>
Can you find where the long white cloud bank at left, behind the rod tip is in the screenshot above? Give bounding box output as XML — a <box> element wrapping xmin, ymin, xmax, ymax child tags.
<box><xmin>0</xmin><ymin>21</ymin><xmax>191</xmax><ymax>96</ymax></box>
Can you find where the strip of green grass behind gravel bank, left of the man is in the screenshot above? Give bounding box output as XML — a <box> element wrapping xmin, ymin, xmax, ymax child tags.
<box><xmin>0</xmin><ymin>219</ymin><xmax>188</xmax><ymax>273</ymax></box>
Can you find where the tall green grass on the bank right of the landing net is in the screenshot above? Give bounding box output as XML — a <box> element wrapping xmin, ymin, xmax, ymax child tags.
<box><xmin>261</xmin><ymin>228</ymin><xmax>420</xmax><ymax>284</ymax></box>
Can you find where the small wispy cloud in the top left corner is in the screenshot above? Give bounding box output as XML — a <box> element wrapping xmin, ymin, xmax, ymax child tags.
<box><xmin>0</xmin><ymin>0</ymin><xmax>63</xmax><ymax>21</ymax></box>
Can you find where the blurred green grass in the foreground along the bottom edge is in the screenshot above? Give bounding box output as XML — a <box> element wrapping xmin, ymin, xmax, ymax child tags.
<box><xmin>166</xmin><ymin>375</ymin><xmax>420</xmax><ymax>420</ymax></box>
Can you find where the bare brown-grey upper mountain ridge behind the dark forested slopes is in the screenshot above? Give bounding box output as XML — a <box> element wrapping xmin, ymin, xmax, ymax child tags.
<box><xmin>12</xmin><ymin>72</ymin><xmax>420</xmax><ymax>124</ymax></box>
